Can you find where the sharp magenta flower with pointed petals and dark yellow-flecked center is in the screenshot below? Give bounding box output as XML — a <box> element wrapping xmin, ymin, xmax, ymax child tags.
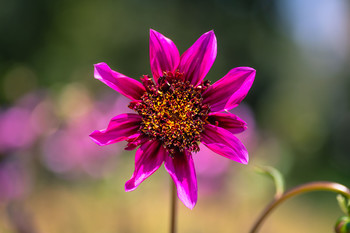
<box><xmin>90</xmin><ymin>29</ymin><xmax>255</xmax><ymax>209</ymax></box>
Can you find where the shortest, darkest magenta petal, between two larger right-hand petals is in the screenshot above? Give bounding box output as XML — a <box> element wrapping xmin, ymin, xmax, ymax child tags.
<box><xmin>208</xmin><ymin>112</ymin><xmax>247</xmax><ymax>134</ymax></box>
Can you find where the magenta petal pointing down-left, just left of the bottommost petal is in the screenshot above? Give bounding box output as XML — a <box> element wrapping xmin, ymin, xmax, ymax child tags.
<box><xmin>125</xmin><ymin>141</ymin><xmax>166</xmax><ymax>192</ymax></box>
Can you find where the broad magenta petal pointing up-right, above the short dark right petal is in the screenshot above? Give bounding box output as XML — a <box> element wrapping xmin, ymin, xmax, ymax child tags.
<box><xmin>203</xmin><ymin>67</ymin><xmax>255</xmax><ymax>112</ymax></box>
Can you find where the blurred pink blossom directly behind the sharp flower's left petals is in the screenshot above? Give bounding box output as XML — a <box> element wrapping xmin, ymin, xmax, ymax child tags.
<box><xmin>42</xmin><ymin>91</ymin><xmax>128</xmax><ymax>178</ymax></box>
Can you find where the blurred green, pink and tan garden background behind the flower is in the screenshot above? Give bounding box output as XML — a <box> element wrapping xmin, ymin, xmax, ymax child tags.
<box><xmin>0</xmin><ymin>0</ymin><xmax>350</xmax><ymax>233</ymax></box>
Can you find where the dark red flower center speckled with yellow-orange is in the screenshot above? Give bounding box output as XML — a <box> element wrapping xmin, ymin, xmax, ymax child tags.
<box><xmin>129</xmin><ymin>72</ymin><xmax>210</xmax><ymax>155</ymax></box>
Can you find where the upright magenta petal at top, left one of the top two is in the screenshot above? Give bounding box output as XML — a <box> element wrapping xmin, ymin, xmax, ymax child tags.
<box><xmin>149</xmin><ymin>29</ymin><xmax>180</xmax><ymax>83</ymax></box>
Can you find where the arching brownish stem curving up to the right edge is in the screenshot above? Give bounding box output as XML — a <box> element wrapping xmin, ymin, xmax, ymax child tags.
<box><xmin>250</xmin><ymin>181</ymin><xmax>350</xmax><ymax>233</ymax></box>
